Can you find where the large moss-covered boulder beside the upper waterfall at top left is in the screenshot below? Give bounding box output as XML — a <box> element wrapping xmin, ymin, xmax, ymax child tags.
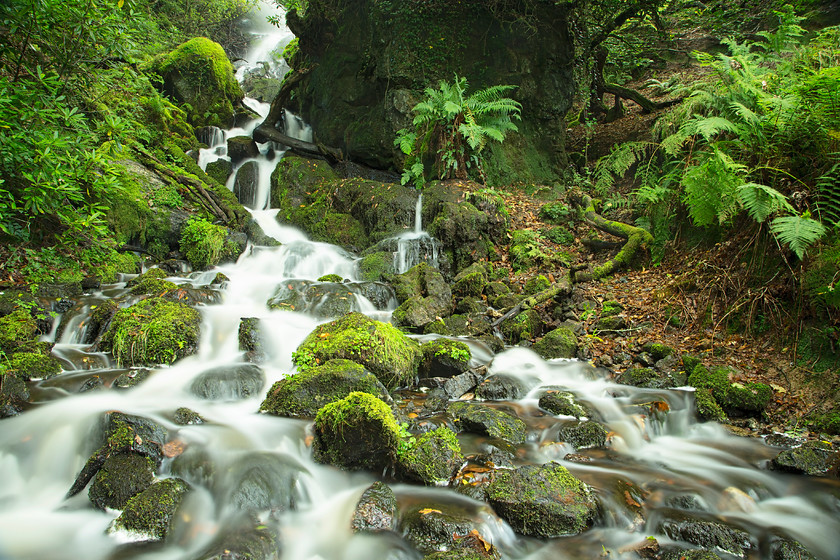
<box><xmin>149</xmin><ymin>37</ymin><xmax>244</xmax><ymax>128</ymax></box>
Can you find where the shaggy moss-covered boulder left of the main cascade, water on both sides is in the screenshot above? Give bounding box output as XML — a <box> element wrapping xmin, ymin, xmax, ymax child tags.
<box><xmin>100</xmin><ymin>297</ymin><xmax>201</xmax><ymax>366</ymax></box>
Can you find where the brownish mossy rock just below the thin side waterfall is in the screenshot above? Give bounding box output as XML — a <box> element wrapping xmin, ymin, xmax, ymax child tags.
<box><xmin>392</xmin><ymin>263</ymin><xmax>454</xmax><ymax>329</ymax></box>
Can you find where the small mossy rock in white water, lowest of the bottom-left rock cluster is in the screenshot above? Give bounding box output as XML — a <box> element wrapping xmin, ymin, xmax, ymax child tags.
<box><xmin>109</xmin><ymin>478</ymin><xmax>190</xmax><ymax>541</ymax></box>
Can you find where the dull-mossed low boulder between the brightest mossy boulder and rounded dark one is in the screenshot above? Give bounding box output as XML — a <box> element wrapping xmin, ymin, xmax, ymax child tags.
<box><xmin>260</xmin><ymin>360</ymin><xmax>392</xmax><ymax>418</ymax></box>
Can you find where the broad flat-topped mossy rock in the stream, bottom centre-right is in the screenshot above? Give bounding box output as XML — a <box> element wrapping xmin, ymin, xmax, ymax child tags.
<box><xmin>487</xmin><ymin>463</ymin><xmax>597</xmax><ymax>538</ymax></box>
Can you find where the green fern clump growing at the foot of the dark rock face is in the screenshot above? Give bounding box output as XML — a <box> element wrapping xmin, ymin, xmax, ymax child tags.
<box><xmin>394</xmin><ymin>75</ymin><xmax>521</xmax><ymax>188</ymax></box>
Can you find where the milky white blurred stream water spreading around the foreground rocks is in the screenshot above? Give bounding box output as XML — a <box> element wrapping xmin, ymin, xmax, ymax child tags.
<box><xmin>0</xmin><ymin>4</ymin><xmax>840</xmax><ymax>560</ymax></box>
